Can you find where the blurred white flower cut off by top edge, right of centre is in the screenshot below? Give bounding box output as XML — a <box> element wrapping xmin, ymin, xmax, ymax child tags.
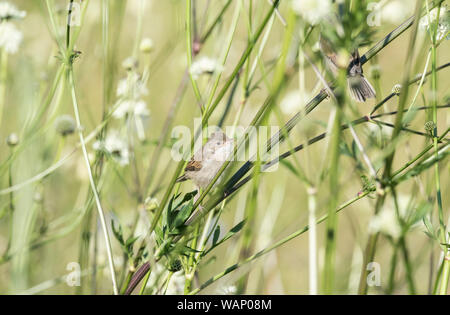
<box><xmin>292</xmin><ymin>0</ymin><xmax>332</xmax><ymax>25</ymax></box>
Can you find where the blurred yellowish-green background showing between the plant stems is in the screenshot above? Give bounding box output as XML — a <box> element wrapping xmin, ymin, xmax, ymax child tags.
<box><xmin>0</xmin><ymin>0</ymin><xmax>450</xmax><ymax>294</ymax></box>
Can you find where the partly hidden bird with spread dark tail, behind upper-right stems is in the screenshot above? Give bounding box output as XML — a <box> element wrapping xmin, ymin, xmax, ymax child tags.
<box><xmin>319</xmin><ymin>36</ymin><xmax>375</xmax><ymax>102</ymax></box>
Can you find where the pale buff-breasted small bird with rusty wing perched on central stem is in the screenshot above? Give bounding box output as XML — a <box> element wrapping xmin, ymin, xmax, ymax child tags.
<box><xmin>176</xmin><ymin>131</ymin><xmax>234</xmax><ymax>188</ymax></box>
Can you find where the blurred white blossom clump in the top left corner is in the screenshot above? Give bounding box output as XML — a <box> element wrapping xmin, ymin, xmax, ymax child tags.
<box><xmin>0</xmin><ymin>2</ymin><xmax>26</xmax><ymax>54</ymax></box>
